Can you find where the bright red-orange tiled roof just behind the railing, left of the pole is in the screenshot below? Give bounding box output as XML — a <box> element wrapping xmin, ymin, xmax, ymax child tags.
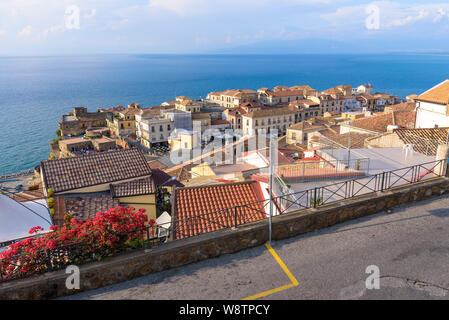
<box><xmin>173</xmin><ymin>181</ymin><xmax>266</xmax><ymax>239</ymax></box>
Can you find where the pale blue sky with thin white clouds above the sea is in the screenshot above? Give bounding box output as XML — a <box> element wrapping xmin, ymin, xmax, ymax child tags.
<box><xmin>0</xmin><ymin>0</ymin><xmax>449</xmax><ymax>55</ymax></box>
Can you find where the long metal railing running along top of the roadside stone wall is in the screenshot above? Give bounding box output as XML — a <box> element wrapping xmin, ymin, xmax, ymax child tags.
<box><xmin>0</xmin><ymin>159</ymin><xmax>447</xmax><ymax>282</ymax></box>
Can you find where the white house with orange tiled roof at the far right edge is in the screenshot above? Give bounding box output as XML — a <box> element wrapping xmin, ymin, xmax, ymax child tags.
<box><xmin>415</xmin><ymin>80</ymin><xmax>449</xmax><ymax>128</ymax></box>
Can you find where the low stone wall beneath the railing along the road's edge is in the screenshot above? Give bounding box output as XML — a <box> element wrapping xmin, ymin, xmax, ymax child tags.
<box><xmin>0</xmin><ymin>178</ymin><xmax>449</xmax><ymax>299</ymax></box>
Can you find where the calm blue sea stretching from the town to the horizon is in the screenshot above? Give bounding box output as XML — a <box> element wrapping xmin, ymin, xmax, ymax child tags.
<box><xmin>0</xmin><ymin>54</ymin><xmax>449</xmax><ymax>175</ymax></box>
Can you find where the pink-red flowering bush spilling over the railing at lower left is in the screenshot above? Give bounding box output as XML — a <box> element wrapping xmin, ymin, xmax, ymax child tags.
<box><xmin>0</xmin><ymin>207</ymin><xmax>155</xmax><ymax>281</ymax></box>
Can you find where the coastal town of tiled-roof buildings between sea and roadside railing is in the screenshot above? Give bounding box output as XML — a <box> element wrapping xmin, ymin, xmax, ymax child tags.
<box><xmin>0</xmin><ymin>80</ymin><xmax>449</xmax><ymax>298</ymax></box>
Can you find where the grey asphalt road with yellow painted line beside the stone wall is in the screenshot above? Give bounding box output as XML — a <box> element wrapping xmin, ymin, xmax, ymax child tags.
<box><xmin>62</xmin><ymin>196</ymin><xmax>449</xmax><ymax>300</ymax></box>
